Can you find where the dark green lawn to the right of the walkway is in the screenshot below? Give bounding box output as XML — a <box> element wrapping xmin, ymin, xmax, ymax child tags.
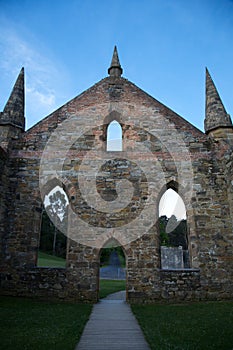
<box><xmin>132</xmin><ymin>302</ymin><xmax>233</xmax><ymax>350</ymax></box>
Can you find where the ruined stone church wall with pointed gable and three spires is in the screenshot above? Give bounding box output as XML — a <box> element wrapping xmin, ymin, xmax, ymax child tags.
<box><xmin>0</xmin><ymin>48</ymin><xmax>233</xmax><ymax>303</ymax></box>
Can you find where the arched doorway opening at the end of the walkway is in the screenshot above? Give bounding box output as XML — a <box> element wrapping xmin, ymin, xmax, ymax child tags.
<box><xmin>99</xmin><ymin>244</ymin><xmax>126</xmax><ymax>300</ymax></box>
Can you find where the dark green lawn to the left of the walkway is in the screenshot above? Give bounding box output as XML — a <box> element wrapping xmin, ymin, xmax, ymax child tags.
<box><xmin>0</xmin><ymin>297</ymin><xmax>92</xmax><ymax>350</ymax></box>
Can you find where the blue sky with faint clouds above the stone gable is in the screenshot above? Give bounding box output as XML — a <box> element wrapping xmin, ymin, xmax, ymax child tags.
<box><xmin>0</xmin><ymin>0</ymin><xmax>233</xmax><ymax>130</ymax></box>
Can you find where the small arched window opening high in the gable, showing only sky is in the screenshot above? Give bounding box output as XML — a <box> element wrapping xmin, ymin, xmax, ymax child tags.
<box><xmin>107</xmin><ymin>120</ymin><xmax>123</xmax><ymax>151</ymax></box>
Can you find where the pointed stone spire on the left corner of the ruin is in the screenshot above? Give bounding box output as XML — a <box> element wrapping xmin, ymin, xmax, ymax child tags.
<box><xmin>0</xmin><ymin>68</ymin><xmax>25</xmax><ymax>130</ymax></box>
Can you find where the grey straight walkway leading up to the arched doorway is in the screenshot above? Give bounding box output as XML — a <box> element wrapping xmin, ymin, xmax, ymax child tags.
<box><xmin>75</xmin><ymin>292</ymin><xmax>150</xmax><ymax>350</ymax></box>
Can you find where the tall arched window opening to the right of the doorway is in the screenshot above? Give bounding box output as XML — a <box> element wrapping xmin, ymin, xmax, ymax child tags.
<box><xmin>159</xmin><ymin>188</ymin><xmax>190</xmax><ymax>269</ymax></box>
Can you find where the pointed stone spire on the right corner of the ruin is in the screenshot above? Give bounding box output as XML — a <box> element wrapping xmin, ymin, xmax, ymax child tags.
<box><xmin>204</xmin><ymin>68</ymin><xmax>232</xmax><ymax>133</ymax></box>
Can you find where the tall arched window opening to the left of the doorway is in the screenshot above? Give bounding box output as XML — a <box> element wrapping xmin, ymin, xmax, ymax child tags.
<box><xmin>37</xmin><ymin>186</ymin><xmax>69</xmax><ymax>267</ymax></box>
